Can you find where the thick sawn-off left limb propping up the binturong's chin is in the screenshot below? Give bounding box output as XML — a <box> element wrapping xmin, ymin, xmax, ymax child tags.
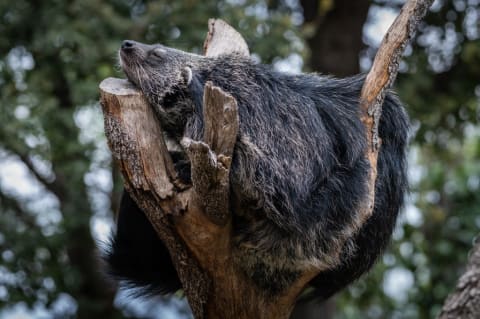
<box><xmin>100</xmin><ymin>78</ymin><xmax>210</xmax><ymax>318</ymax></box>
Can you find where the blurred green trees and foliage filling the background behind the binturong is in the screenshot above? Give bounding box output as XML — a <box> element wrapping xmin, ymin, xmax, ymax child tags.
<box><xmin>0</xmin><ymin>0</ymin><xmax>480</xmax><ymax>318</ymax></box>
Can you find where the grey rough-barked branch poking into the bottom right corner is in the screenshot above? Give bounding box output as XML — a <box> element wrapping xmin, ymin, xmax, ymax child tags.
<box><xmin>438</xmin><ymin>242</ymin><xmax>480</xmax><ymax>319</ymax></box>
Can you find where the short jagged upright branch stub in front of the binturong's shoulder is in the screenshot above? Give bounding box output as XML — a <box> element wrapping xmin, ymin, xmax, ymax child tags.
<box><xmin>182</xmin><ymin>82</ymin><xmax>238</xmax><ymax>226</ymax></box>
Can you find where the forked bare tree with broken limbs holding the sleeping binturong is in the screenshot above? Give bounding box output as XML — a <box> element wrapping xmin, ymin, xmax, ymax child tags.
<box><xmin>100</xmin><ymin>5</ymin><xmax>431</xmax><ymax>319</ymax></box>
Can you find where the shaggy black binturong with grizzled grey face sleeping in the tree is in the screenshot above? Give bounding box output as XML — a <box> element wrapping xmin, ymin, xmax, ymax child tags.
<box><xmin>105</xmin><ymin>40</ymin><xmax>409</xmax><ymax>301</ymax></box>
